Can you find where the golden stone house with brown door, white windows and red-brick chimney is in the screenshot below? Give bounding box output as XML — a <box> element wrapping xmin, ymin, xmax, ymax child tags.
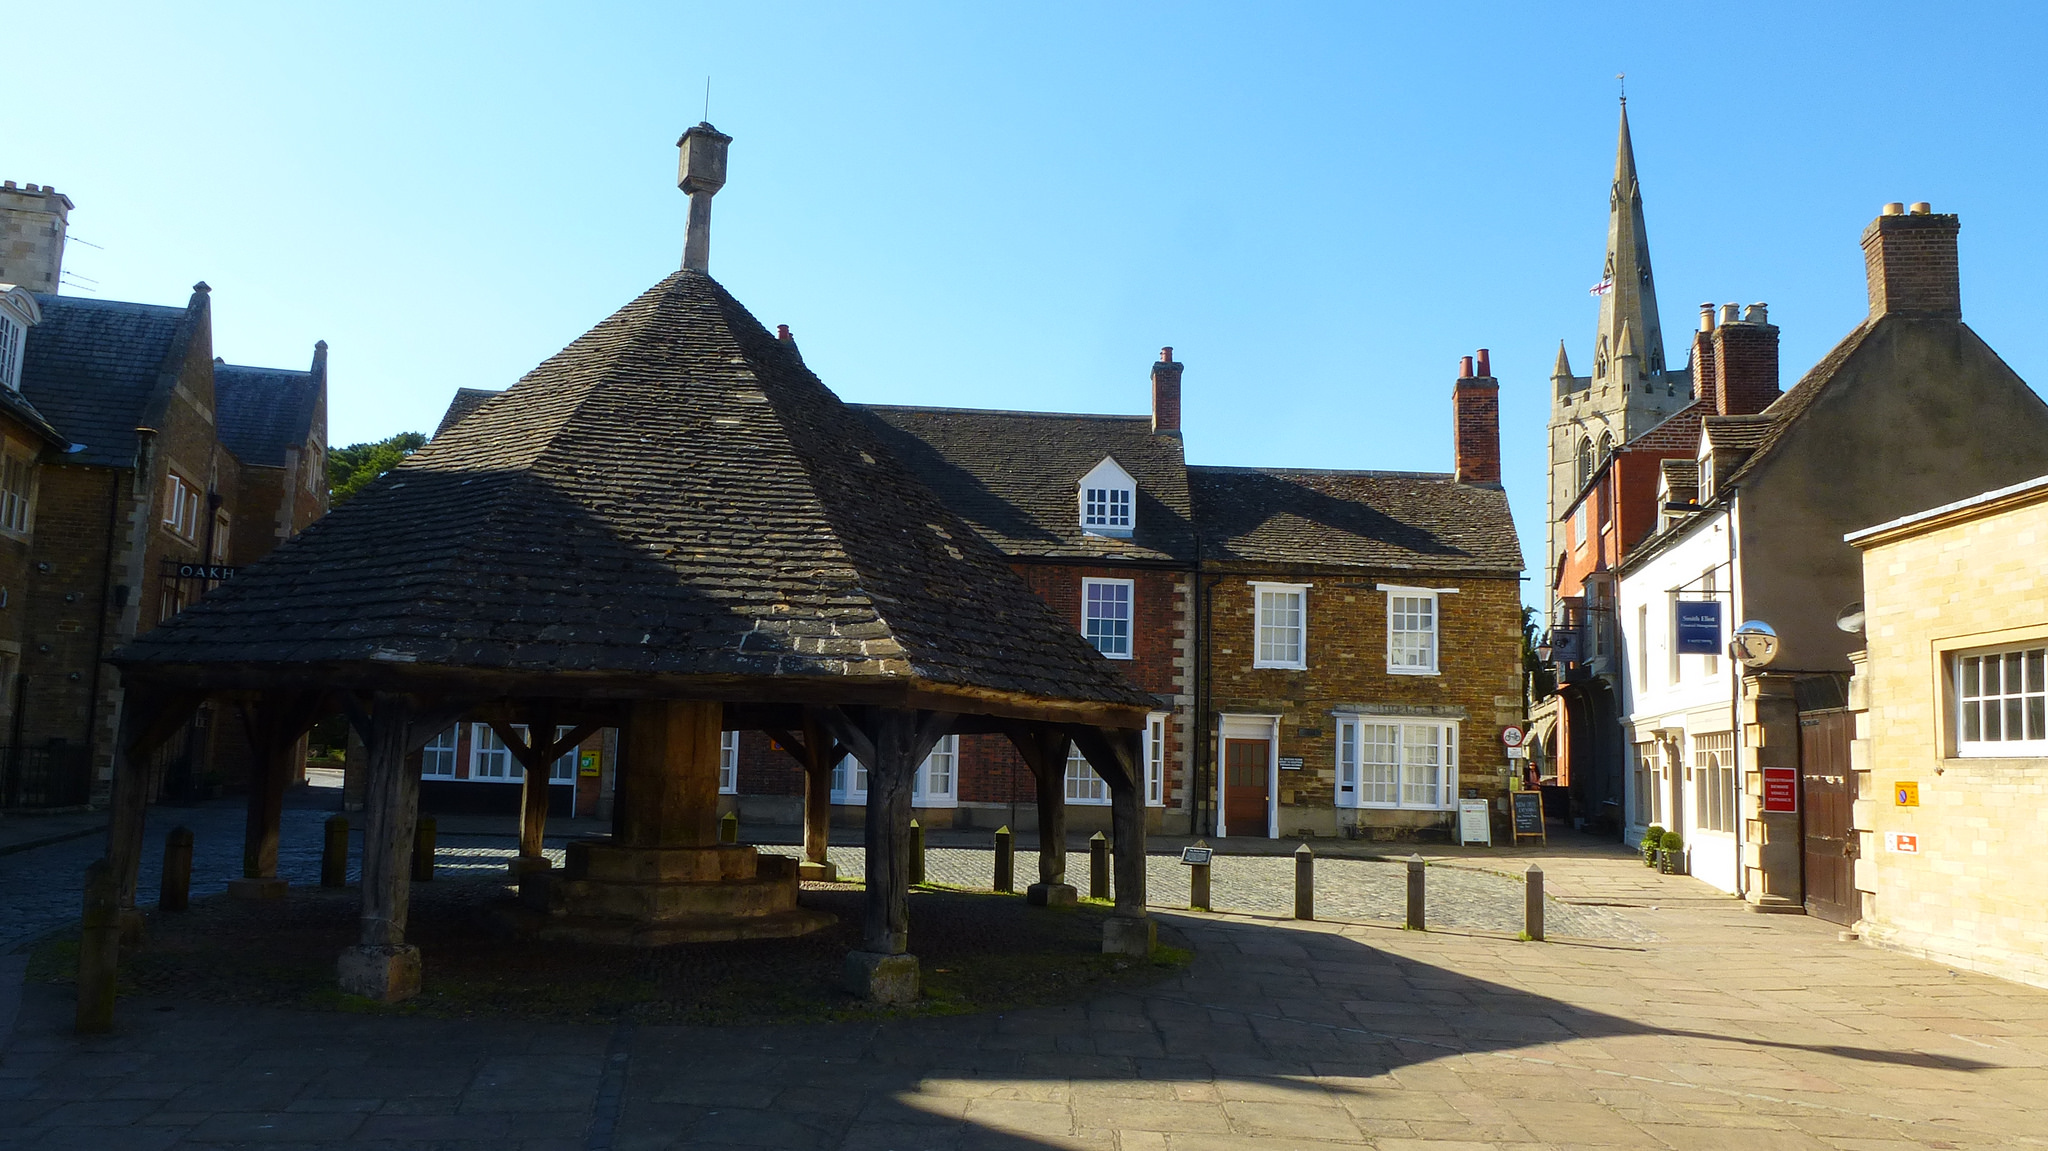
<box><xmin>1188</xmin><ymin>352</ymin><xmax>1522</xmax><ymax>838</ymax></box>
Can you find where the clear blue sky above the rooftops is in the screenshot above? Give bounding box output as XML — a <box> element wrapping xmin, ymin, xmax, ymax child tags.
<box><xmin>16</xmin><ymin>0</ymin><xmax>2048</xmax><ymax>610</ymax></box>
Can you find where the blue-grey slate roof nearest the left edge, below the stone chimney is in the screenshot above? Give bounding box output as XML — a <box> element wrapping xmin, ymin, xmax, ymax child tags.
<box><xmin>20</xmin><ymin>295</ymin><xmax>186</xmax><ymax>467</ymax></box>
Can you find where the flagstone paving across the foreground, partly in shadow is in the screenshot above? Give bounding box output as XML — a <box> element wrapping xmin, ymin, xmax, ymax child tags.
<box><xmin>0</xmin><ymin>831</ymin><xmax>2048</xmax><ymax>1151</ymax></box>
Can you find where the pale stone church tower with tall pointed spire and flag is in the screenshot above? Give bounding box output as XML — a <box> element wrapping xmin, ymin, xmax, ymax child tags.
<box><xmin>1542</xmin><ymin>96</ymin><xmax>1692</xmax><ymax>598</ymax></box>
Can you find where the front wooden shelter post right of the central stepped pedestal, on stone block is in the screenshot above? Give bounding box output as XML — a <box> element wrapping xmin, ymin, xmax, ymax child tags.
<box><xmin>821</xmin><ymin>709</ymin><xmax>952</xmax><ymax>1004</ymax></box>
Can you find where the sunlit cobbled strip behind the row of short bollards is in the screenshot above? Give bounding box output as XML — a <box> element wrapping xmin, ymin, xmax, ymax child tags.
<box><xmin>764</xmin><ymin>846</ymin><xmax>1657</xmax><ymax>942</ymax></box>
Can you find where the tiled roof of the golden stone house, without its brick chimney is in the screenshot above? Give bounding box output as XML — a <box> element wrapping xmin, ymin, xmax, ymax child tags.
<box><xmin>1188</xmin><ymin>467</ymin><xmax>1522</xmax><ymax>573</ymax></box>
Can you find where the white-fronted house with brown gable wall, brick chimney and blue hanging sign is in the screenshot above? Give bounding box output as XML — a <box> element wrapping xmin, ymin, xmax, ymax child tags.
<box><xmin>1616</xmin><ymin>203</ymin><xmax>2048</xmax><ymax>911</ymax></box>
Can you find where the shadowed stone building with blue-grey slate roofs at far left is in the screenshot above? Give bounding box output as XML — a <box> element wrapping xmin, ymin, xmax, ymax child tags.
<box><xmin>0</xmin><ymin>181</ymin><xmax>328</xmax><ymax>805</ymax></box>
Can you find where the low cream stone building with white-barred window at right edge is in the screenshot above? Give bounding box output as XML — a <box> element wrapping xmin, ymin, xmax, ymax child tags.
<box><xmin>1843</xmin><ymin>475</ymin><xmax>2048</xmax><ymax>987</ymax></box>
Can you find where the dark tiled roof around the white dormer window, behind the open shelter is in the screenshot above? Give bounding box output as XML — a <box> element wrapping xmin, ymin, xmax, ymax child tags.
<box><xmin>860</xmin><ymin>406</ymin><xmax>1194</xmax><ymax>563</ymax></box>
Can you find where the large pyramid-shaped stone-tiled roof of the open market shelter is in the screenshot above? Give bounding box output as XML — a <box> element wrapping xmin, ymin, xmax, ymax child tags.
<box><xmin>119</xmin><ymin>270</ymin><xmax>1151</xmax><ymax>707</ymax></box>
